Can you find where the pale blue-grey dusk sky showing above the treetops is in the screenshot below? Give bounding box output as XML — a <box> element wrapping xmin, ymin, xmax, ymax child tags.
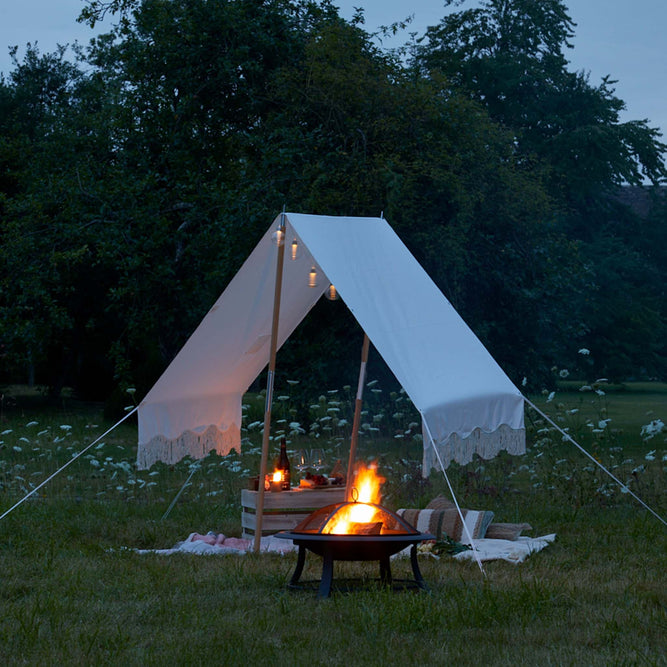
<box><xmin>0</xmin><ymin>0</ymin><xmax>667</xmax><ymax>140</ymax></box>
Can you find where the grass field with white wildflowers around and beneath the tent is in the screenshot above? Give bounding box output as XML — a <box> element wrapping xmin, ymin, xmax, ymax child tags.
<box><xmin>0</xmin><ymin>385</ymin><xmax>667</xmax><ymax>665</ymax></box>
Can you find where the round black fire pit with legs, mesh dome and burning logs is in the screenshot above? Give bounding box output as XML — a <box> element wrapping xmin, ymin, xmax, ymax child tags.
<box><xmin>276</xmin><ymin>502</ymin><xmax>435</xmax><ymax>598</ymax></box>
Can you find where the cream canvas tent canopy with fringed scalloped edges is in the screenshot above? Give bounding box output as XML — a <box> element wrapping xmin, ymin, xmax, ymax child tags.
<box><xmin>137</xmin><ymin>213</ymin><xmax>525</xmax><ymax>474</ymax></box>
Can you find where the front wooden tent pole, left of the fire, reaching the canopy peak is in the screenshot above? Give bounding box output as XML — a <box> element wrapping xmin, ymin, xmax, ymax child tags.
<box><xmin>253</xmin><ymin>218</ymin><xmax>285</xmax><ymax>553</ymax></box>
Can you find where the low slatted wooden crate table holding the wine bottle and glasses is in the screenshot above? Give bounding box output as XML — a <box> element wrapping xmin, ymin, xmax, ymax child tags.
<box><xmin>241</xmin><ymin>485</ymin><xmax>345</xmax><ymax>539</ymax></box>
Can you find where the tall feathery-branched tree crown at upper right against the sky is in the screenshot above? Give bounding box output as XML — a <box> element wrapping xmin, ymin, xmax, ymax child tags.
<box><xmin>415</xmin><ymin>0</ymin><xmax>667</xmax><ymax>201</ymax></box>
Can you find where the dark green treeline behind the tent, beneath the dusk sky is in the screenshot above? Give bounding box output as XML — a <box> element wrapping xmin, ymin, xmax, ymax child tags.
<box><xmin>0</xmin><ymin>0</ymin><xmax>667</xmax><ymax>410</ymax></box>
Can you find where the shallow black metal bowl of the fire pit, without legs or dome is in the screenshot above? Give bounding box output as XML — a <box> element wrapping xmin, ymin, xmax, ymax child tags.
<box><xmin>275</xmin><ymin>530</ymin><xmax>435</xmax><ymax>561</ymax></box>
